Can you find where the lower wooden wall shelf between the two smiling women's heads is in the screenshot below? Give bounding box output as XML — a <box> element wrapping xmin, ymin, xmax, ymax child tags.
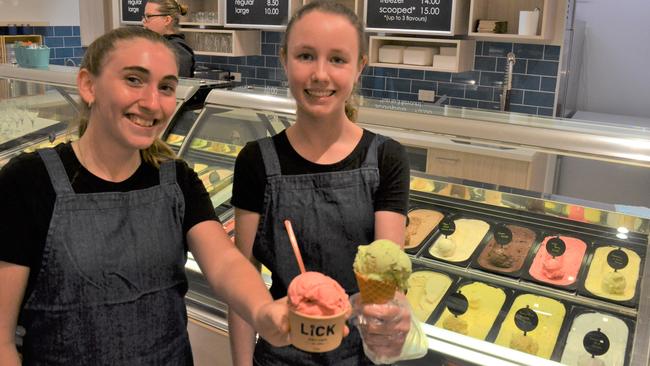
<box><xmin>180</xmin><ymin>28</ymin><xmax>262</xmax><ymax>57</ymax></box>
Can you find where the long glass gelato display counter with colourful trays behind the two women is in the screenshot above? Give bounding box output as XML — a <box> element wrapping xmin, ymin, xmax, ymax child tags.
<box><xmin>173</xmin><ymin>88</ymin><xmax>650</xmax><ymax>365</ymax></box>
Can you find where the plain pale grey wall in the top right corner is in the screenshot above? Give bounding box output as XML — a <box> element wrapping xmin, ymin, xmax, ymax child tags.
<box><xmin>576</xmin><ymin>0</ymin><xmax>650</xmax><ymax>118</ymax></box>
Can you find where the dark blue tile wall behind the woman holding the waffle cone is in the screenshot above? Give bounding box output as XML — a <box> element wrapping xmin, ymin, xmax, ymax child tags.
<box><xmin>198</xmin><ymin>32</ymin><xmax>560</xmax><ymax>115</ymax></box>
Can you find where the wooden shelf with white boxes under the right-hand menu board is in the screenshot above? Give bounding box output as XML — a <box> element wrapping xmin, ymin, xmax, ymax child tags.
<box><xmin>368</xmin><ymin>36</ymin><xmax>476</xmax><ymax>73</ymax></box>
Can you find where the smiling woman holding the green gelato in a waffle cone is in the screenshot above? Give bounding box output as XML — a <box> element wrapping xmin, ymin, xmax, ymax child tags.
<box><xmin>229</xmin><ymin>1</ymin><xmax>410</xmax><ymax>366</ymax></box>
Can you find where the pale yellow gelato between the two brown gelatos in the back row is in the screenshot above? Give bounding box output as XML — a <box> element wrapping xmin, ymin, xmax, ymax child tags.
<box><xmin>429</xmin><ymin>219</ymin><xmax>490</xmax><ymax>262</ymax></box>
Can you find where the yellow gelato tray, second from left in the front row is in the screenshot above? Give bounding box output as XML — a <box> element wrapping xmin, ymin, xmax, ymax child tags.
<box><xmin>434</xmin><ymin>281</ymin><xmax>512</xmax><ymax>340</ymax></box>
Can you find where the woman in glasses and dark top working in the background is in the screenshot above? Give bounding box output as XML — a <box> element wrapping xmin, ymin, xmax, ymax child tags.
<box><xmin>142</xmin><ymin>0</ymin><xmax>195</xmax><ymax>78</ymax></box>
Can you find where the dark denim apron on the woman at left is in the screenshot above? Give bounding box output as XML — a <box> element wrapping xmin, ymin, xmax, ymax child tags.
<box><xmin>23</xmin><ymin>149</ymin><xmax>192</xmax><ymax>365</ymax></box>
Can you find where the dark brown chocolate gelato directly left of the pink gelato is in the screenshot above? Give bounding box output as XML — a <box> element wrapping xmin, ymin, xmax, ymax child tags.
<box><xmin>478</xmin><ymin>225</ymin><xmax>535</xmax><ymax>273</ymax></box>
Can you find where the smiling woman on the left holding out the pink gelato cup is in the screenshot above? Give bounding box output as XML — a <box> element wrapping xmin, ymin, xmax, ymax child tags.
<box><xmin>0</xmin><ymin>27</ymin><xmax>288</xmax><ymax>366</ymax></box>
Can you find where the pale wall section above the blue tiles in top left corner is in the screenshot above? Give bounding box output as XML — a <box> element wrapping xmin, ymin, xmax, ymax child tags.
<box><xmin>0</xmin><ymin>0</ymin><xmax>83</xmax><ymax>25</ymax></box>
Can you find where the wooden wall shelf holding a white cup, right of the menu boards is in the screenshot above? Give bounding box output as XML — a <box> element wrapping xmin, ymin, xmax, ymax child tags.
<box><xmin>467</xmin><ymin>0</ymin><xmax>566</xmax><ymax>42</ymax></box>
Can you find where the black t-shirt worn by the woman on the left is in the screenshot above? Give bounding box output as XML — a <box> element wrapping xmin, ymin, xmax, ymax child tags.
<box><xmin>0</xmin><ymin>143</ymin><xmax>218</xmax><ymax>296</ymax></box>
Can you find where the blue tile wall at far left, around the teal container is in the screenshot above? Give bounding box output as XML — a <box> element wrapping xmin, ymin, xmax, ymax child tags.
<box><xmin>0</xmin><ymin>25</ymin><xmax>86</xmax><ymax>66</ymax></box>
